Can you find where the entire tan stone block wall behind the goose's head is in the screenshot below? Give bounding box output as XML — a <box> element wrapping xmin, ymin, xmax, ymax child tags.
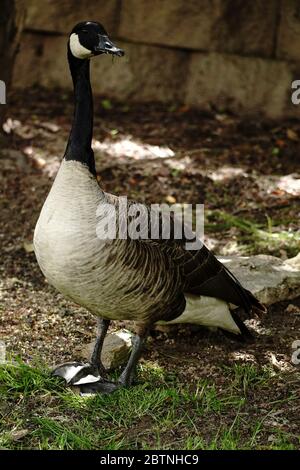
<box><xmin>13</xmin><ymin>0</ymin><xmax>300</xmax><ymax>120</ymax></box>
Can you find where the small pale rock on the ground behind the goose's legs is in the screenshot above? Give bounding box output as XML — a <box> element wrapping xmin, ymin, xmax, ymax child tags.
<box><xmin>82</xmin><ymin>330</ymin><xmax>133</xmax><ymax>369</ymax></box>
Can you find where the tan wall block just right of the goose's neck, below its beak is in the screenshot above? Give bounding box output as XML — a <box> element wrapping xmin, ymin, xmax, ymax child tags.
<box><xmin>91</xmin><ymin>41</ymin><xmax>189</xmax><ymax>102</ymax></box>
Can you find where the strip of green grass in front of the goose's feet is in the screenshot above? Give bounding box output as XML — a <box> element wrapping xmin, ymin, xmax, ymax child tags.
<box><xmin>0</xmin><ymin>360</ymin><xmax>299</xmax><ymax>450</ymax></box>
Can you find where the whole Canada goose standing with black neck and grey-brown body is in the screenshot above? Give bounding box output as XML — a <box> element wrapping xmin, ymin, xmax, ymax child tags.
<box><xmin>34</xmin><ymin>21</ymin><xmax>265</xmax><ymax>393</ymax></box>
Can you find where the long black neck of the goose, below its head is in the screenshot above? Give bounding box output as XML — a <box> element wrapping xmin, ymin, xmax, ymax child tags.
<box><xmin>64</xmin><ymin>46</ymin><xmax>96</xmax><ymax>175</ymax></box>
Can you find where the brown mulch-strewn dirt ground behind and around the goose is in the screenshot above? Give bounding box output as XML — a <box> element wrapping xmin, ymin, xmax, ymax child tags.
<box><xmin>0</xmin><ymin>89</ymin><xmax>300</xmax><ymax>444</ymax></box>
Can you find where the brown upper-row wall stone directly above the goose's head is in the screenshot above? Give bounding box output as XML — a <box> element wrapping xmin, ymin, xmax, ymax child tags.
<box><xmin>25</xmin><ymin>0</ymin><xmax>120</xmax><ymax>34</ymax></box>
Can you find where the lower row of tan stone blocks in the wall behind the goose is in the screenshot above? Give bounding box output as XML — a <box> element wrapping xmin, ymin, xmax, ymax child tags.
<box><xmin>13</xmin><ymin>32</ymin><xmax>300</xmax><ymax>118</ymax></box>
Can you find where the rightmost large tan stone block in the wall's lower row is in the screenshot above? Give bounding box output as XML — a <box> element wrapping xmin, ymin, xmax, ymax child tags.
<box><xmin>184</xmin><ymin>53</ymin><xmax>294</xmax><ymax>118</ymax></box>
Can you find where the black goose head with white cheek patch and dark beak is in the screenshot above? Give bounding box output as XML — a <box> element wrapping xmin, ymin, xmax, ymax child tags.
<box><xmin>69</xmin><ymin>21</ymin><xmax>124</xmax><ymax>60</ymax></box>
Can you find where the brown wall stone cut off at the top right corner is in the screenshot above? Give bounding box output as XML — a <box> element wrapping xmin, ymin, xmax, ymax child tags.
<box><xmin>277</xmin><ymin>0</ymin><xmax>300</xmax><ymax>61</ymax></box>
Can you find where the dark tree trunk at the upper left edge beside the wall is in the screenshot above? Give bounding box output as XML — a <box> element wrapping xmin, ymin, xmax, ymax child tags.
<box><xmin>0</xmin><ymin>0</ymin><xmax>25</xmax><ymax>148</ymax></box>
